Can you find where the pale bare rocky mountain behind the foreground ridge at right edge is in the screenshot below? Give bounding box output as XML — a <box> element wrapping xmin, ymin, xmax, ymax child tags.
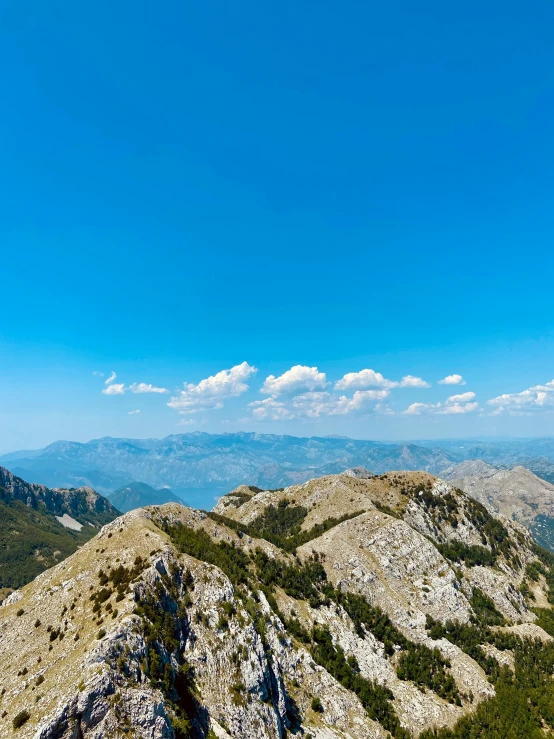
<box><xmin>451</xmin><ymin>466</ymin><xmax>554</xmax><ymax>552</ymax></box>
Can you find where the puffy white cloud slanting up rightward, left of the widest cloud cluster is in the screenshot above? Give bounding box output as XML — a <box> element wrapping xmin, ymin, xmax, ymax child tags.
<box><xmin>167</xmin><ymin>362</ymin><xmax>257</xmax><ymax>413</ymax></box>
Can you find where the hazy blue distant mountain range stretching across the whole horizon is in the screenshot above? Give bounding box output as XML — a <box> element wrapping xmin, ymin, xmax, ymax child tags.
<box><xmin>0</xmin><ymin>432</ymin><xmax>554</xmax><ymax>508</ymax></box>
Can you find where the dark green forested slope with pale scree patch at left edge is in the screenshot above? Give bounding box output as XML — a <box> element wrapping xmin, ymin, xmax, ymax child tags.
<box><xmin>0</xmin><ymin>467</ymin><xmax>119</xmax><ymax>589</ymax></box>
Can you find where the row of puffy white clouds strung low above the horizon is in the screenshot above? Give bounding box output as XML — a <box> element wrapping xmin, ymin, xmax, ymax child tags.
<box><xmin>97</xmin><ymin>361</ymin><xmax>554</xmax><ymax>423</ymax></box>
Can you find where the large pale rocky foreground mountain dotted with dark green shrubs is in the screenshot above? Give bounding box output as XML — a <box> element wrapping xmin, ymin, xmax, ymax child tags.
<box><xmin>0</xmin><ymin>472</ymin><xmax>554</xmax><ymax>739</ymax></box>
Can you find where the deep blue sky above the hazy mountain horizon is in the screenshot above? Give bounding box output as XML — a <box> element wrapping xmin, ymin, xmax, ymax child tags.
<box><xmin>0</xmin><ymin>0</ymin><xmax>554</xmax><ymax>451</ymax></box>
